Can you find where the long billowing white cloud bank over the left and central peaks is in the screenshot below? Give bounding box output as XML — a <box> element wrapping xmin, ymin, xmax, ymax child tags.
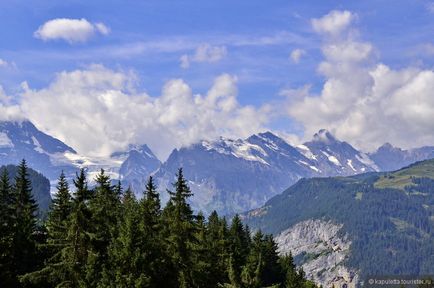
<box><xmin>21</xmin><ymin>65</ymin><xmax>269</xmax><ymax>159</ymax></box>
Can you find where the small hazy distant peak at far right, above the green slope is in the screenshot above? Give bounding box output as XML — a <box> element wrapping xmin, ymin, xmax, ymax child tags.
<box><xmin>369</xmin><ymin>143</ymin><xmax>434</xmax><ymax>171</ymax></box>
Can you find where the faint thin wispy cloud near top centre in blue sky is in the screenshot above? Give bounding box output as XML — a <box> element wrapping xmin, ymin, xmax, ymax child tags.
<box><xmin>180</xmin><ymin>44</ymin><xmax>227</xmax><ymax>68</ymax></box>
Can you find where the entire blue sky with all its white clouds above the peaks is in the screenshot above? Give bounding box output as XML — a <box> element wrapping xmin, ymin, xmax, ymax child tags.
<box><xmin>0</xmin><ymin>0</ymin><xmax>434</xmax><ymax>160</ymax></box>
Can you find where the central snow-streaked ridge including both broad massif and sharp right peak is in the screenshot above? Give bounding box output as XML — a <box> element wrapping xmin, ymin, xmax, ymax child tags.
<box><xmin>155</xmin><ymin>130</ymin><xmax>378</xmax><ymax>214</ymax></box>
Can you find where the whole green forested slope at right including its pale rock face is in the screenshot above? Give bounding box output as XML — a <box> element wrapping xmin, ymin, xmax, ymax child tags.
<box><xmin>243</xmin><ymin>159</ymin><xmax>434</xmax><ymax>287</ymax></box>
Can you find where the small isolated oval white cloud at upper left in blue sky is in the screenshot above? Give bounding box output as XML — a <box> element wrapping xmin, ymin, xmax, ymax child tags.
<box><xmin>33</xmin><ymin>18</ymin><xmax>110</xmax><ymax>44</ymax></box>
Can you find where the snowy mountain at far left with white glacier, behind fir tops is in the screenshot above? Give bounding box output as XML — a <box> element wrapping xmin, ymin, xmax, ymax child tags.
<box><xmin>0</xmin><ymin>121</ymin><xmax>160</xmax><ymax>194</ymax></box>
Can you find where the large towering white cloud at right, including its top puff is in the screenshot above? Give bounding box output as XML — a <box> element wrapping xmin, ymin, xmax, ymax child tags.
<box><xmin>282</xmin><ymin>11</ymin><xmax>434</xmax><ymax>150</ymax></box>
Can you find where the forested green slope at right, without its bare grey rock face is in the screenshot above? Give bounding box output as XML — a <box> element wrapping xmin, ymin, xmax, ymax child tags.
<box><xmin>244</xmin><ymin>160</ymin><xmax>434</xmax><ymax>284</ymax></box>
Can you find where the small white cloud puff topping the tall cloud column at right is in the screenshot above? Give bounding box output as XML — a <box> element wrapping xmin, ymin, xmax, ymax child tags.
<box><xmin>312</xmin><ymin>10</ymin><xmax>356</xmax><ymax>35</ymax></box>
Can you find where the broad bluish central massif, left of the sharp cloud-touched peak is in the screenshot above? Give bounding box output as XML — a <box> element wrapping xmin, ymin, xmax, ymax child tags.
<box><xmin>155</xmin><ymin>133</ymin><xmax>313</xmax><ymax>213</ymax></box>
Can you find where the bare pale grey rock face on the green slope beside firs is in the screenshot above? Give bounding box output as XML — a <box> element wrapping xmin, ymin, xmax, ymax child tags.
<box><xmin>275</xmin><ymin>220</ymin><xmax>359</xmax><ymax>287</ymax></box>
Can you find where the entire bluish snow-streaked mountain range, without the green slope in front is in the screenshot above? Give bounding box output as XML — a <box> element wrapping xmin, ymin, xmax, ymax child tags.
<box><xmin>0</xmin><ymin>121</ymin><xmax>434</xmax><ymax>214</ymax></box>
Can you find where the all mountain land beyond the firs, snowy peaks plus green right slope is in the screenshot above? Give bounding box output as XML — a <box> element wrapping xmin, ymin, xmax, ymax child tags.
<box><xmin>0</xmin><ymin>121</ymin><xmax>434</xmax><ymax>287</ymax></box>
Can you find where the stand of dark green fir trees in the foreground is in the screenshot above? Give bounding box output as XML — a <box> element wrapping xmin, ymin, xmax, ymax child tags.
<box><xmin>11</xmin><ymin>164</ymin><xmax>315</xmax><ymax>288</ymax></box>
